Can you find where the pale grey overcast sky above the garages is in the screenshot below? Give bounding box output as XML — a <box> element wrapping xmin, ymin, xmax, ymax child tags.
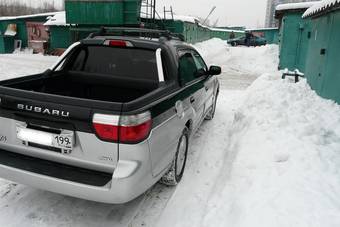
<box><xmin>21</xmin><ymin>0</ymin><xmax>267</xmax><ymax>27</ymax></box>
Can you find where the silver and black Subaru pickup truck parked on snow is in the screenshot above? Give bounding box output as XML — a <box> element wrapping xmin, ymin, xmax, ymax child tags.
<box><xmin>0</xmin><ymin>30</ymin><xmax>221</xmax><ymax>204</ymax></box>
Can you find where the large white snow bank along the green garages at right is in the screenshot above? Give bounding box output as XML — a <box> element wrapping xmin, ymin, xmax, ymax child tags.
<box><xmin>204</xmin><ymin>73</ymin><xmax>340</xmax><ymax>227</ymax></box>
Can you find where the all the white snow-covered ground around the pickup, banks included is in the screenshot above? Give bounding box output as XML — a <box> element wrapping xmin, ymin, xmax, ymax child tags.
<box><xmin>0</xmin><ymin>39</ymin><xmax>340</xmax><ymax>227</ymax></box>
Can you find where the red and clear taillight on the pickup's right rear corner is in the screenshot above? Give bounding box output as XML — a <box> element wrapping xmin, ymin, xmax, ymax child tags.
<box><xmin>93</xmin><ymin>112</ymin><xmax>152</xmax><ymax>143</ymax></box>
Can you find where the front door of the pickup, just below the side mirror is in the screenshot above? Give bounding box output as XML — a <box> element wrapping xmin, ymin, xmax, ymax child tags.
<box><xmin>193</xmin><ymin>51</ymin><xmax>215</xmax><ymax>114</ymax></box>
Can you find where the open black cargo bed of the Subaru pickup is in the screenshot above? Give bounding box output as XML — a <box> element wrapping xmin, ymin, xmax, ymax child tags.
<box><xmin>3</xmin><ymin>71</ymin><xmax>158</xmax><ymax>103</ymax></box>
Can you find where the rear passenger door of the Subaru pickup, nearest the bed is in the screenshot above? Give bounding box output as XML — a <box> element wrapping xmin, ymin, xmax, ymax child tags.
<box><xmin>178</xmin><ymin>50</ymin><xmax>206</xmax><ymax>130</ymax></box>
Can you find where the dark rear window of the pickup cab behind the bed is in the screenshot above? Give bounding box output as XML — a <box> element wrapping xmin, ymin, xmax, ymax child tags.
<box><xmin>71</xmin><ymin>46</ymin><xmax>158</xmax><ymax>80</ymax></box>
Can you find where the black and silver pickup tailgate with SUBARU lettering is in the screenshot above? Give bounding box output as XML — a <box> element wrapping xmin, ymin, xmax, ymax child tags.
<box><xmin>0</xmin><ymin>87</ymin><xmax>122</xmax><ymax>184</ymax></box>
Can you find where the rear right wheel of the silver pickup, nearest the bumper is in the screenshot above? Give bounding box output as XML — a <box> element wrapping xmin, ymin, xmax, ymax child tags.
<box><xmin>160</xmin><ymin>127</ymin><xmax>189</xmax><ymax>186</ymax></box>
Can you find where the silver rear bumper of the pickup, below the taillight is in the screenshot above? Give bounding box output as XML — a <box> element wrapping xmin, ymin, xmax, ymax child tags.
<box><xmin>0</xmin><ymin>141</ymin><xmax>158</xmax><ymax>204</ymax></box>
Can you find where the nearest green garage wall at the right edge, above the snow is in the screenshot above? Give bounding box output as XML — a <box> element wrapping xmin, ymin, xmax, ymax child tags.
<box><xmin>305</xmin><ymin>11</ymin><xmax>340</xmax><ymax>103</ymax></box>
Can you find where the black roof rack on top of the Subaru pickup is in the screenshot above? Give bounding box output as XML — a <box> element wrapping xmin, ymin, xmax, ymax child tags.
<box><xmin>88</xmin><ymin>27</ymin><xmax>185</xmax><ymax>41</ymax></box>
